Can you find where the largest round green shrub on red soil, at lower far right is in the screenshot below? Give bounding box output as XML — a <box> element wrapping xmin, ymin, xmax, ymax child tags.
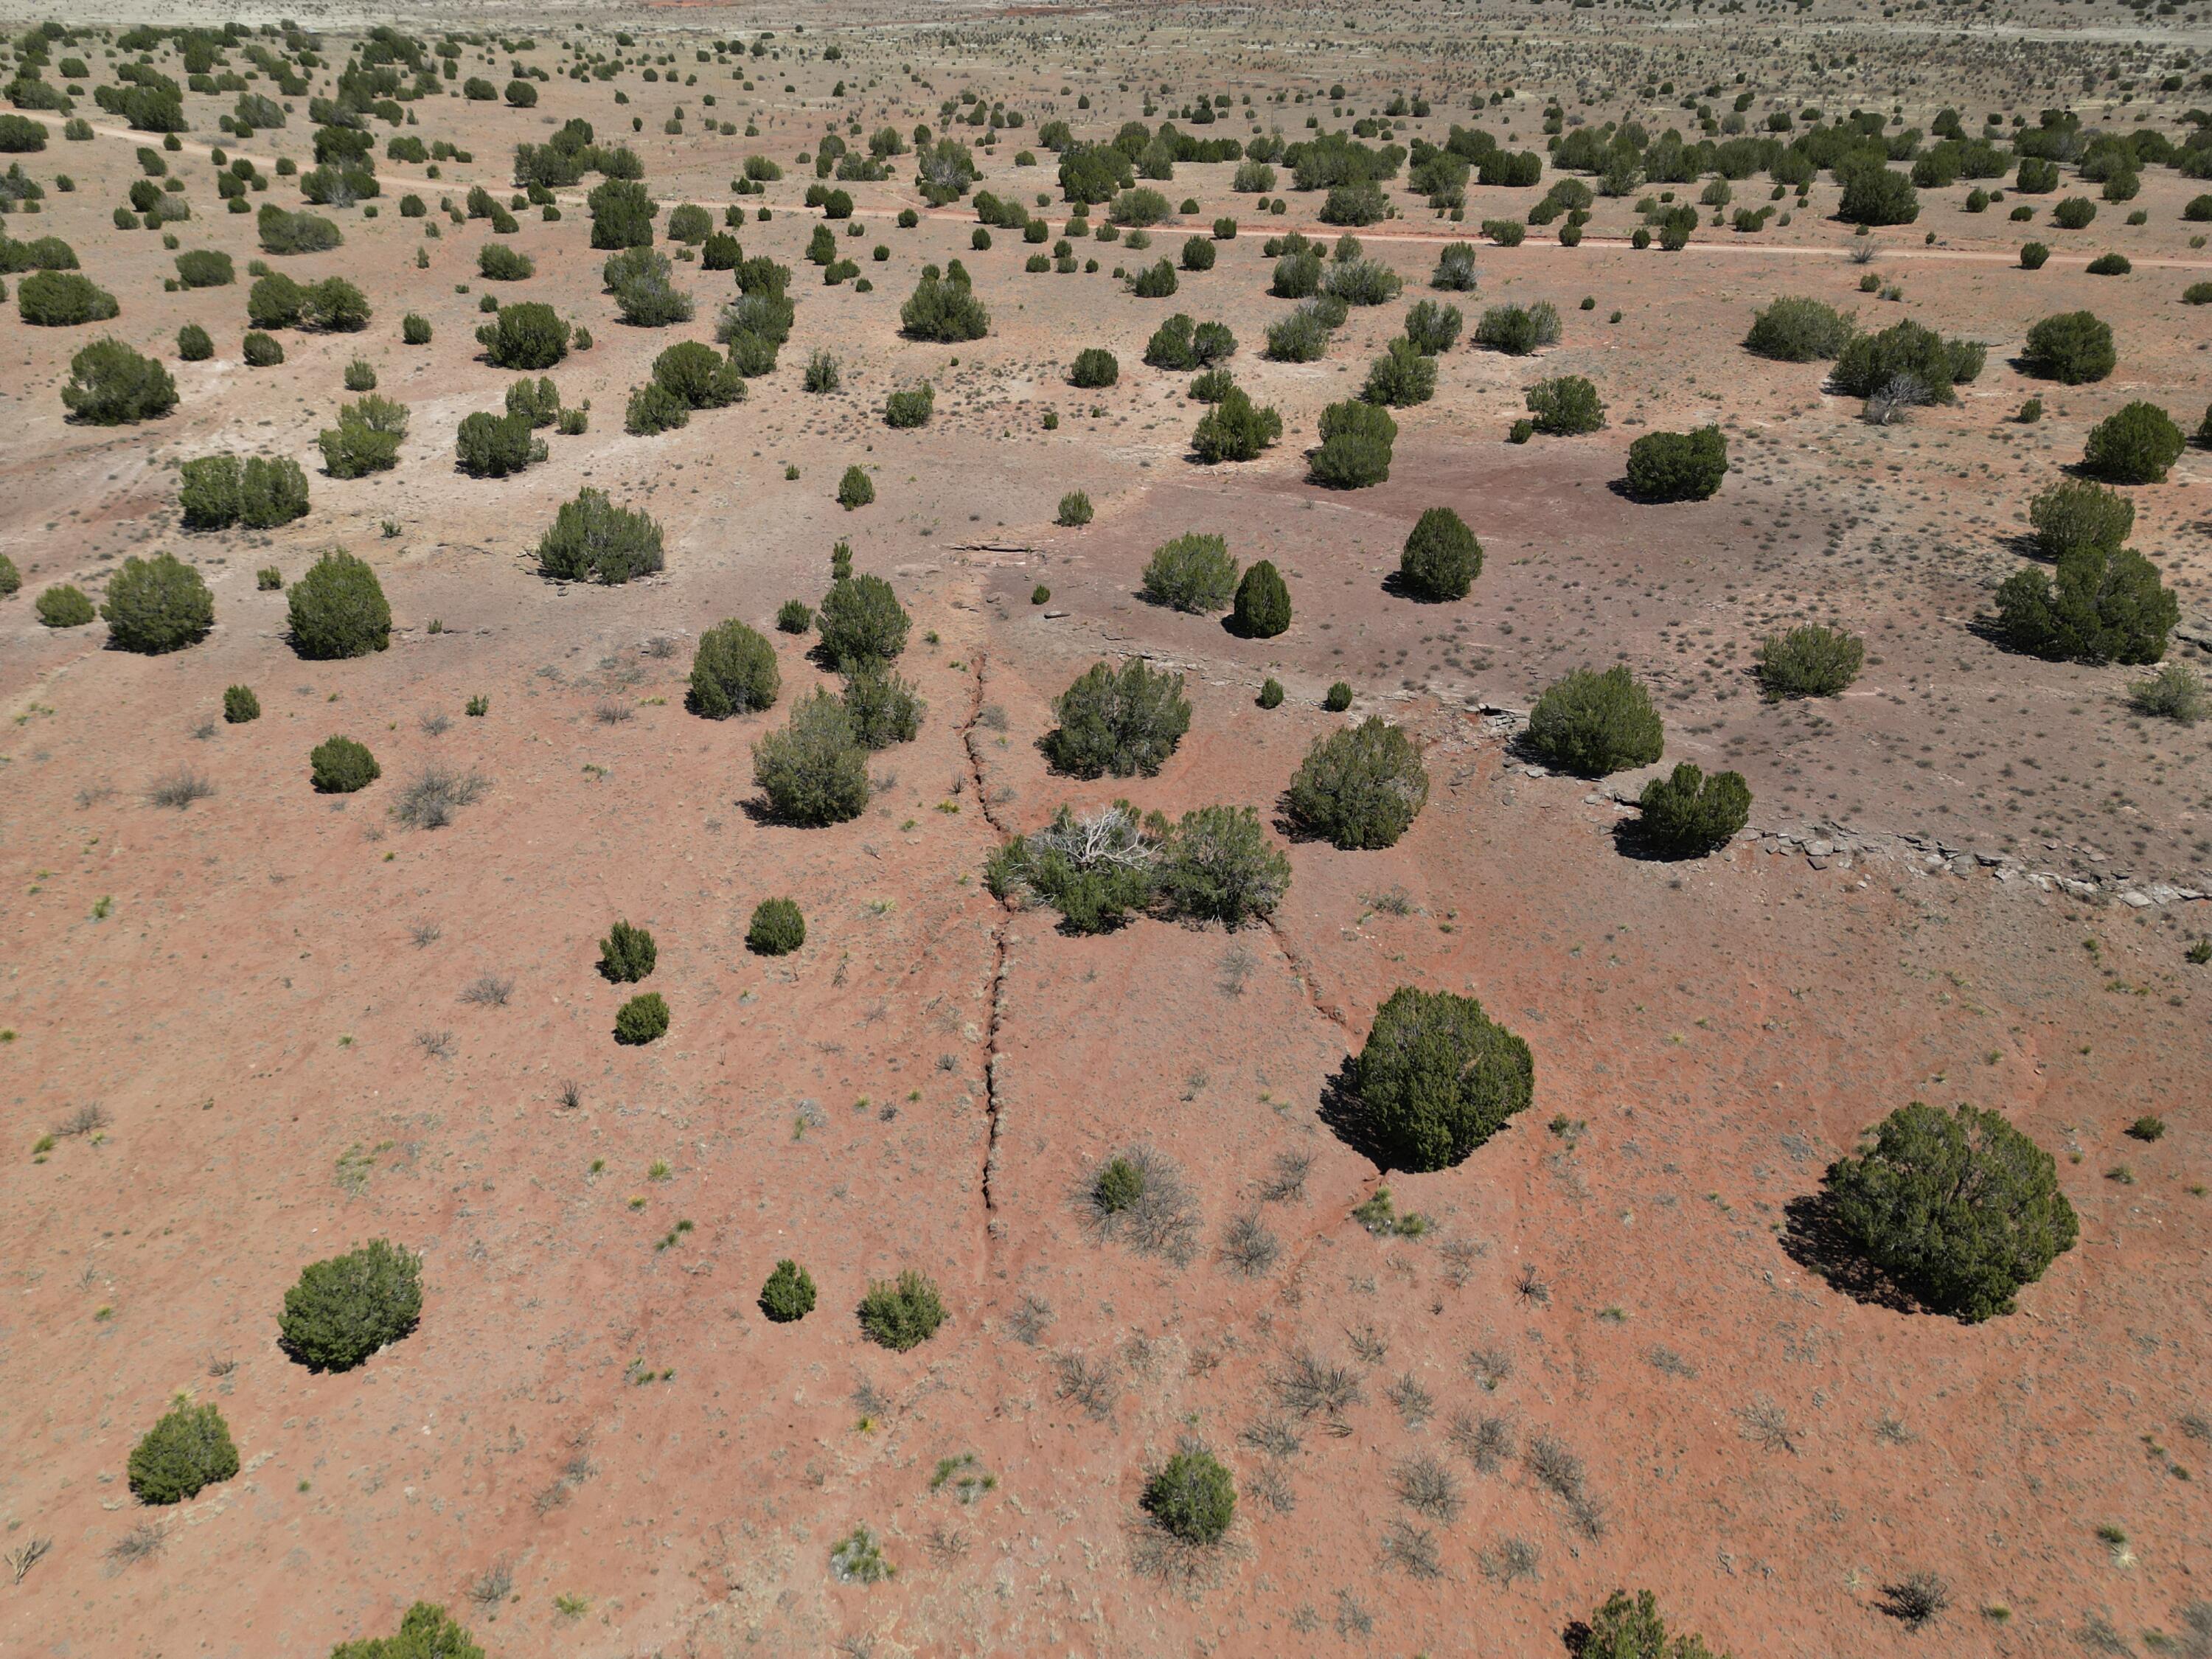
<box><xmin>1827</xmin><ymin>1102</ymin><xmax>2079</xmax><ymax>1323</ymax></box>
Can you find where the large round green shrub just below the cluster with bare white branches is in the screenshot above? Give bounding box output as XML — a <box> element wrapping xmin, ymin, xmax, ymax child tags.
<box><xmin>1352</xmin><ymin>987</ymin><xmax>1535</xmax><ymax>1170</ymax></box>
